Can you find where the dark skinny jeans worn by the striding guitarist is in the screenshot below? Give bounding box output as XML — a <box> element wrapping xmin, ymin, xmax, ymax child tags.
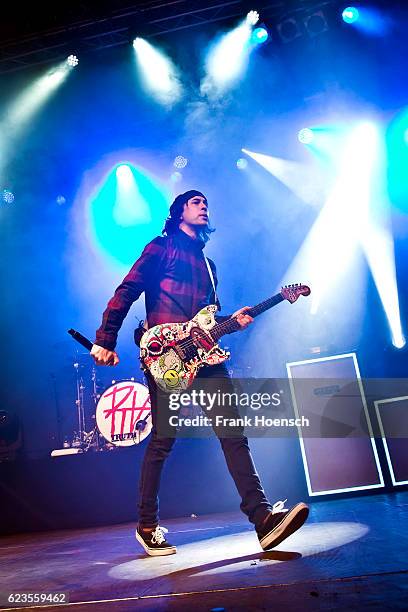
<box><xmin>138</xmin><ymin>364</ymin><xmax>272</xmax><ymax>527</ymax></box>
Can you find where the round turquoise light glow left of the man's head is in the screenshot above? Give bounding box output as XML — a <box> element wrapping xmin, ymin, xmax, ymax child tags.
<box><xmin>83</xmin><ymin>157</ymin><xmax>174</xmax><ymax>266</ymax></box>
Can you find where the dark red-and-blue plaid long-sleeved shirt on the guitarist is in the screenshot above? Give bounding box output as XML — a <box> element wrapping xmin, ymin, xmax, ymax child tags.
<box><xmin>95</xmin><ymin>230</ymin><xmax>224</xmax><ymax>350</ymax></box>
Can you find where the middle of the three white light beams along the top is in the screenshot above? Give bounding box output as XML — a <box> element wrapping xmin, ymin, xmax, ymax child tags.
<box><xmin>133</xmin><ymin>38</ymin><xmax>181</xmax><ymax>106</ymax></box>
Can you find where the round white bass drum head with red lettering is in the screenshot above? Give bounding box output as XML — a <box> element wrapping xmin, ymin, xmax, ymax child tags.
<box><xmin>95</xmin><ymin>380</ymin><xmax>152</xmax><ymax>446</ymax></box>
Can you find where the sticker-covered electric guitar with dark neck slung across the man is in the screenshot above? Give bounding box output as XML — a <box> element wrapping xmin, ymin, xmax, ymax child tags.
<box><xmin>140</xmin><ymin>284</ymin><xmax>310</xmax><ymax>393</ymax></box>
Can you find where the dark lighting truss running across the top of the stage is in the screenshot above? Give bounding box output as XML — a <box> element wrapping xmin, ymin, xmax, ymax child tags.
<box><xmin>0</xmin><ymin>0</ymin><xmax>335</xmax><ymax>74</ymax></box>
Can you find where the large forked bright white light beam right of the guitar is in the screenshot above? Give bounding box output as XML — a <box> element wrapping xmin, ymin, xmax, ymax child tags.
<box><xmin>278</xmin><ymin>123</ymin><xmax>405</xmax><ymax>348</ymax></box>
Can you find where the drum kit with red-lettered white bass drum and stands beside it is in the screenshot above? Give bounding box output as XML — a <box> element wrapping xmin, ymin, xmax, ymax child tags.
<box><xmin>56</xmin><ymin>353</ymin><xmax>152</xmax><ymax>456</ymax></box>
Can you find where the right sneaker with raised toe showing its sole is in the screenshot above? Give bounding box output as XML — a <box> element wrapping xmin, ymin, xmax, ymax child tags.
<box><xmin>256</xmin><ymin>499</ymin><xmax>309</xmax><ymax>550</ymax></box>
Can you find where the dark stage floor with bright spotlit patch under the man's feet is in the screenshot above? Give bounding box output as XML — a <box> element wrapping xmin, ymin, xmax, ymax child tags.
<box><xmin>0</xmin><ymin>491</ymin><xmax>408</xmax><ymax>611</ymax></box>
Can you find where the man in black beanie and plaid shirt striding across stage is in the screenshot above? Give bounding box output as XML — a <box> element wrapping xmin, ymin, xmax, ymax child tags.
<box><xmin>91</xmin><ymin>190</ymin><xmax>309</xmax><ymax>556</ymax></box>
